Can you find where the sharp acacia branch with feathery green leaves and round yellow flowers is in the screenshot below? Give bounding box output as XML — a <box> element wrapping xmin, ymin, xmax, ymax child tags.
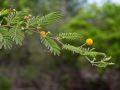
<box><xmin>0</xmin><ymin>9</ymin><xmax>113</xmax><ymax>67</ymax></box>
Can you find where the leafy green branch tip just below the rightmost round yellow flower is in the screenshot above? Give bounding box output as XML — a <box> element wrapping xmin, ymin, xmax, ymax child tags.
<box><xmin>63</xmin><ymin>44</ymin><xmax>114</xmax><ymax>67</ymax></box>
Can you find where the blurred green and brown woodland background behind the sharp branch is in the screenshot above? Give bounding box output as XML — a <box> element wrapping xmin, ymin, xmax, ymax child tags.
<box><xmin>0</xmin><ymin>0</ymin><xmax>120</xmax><ymax>90</ymax></box>
